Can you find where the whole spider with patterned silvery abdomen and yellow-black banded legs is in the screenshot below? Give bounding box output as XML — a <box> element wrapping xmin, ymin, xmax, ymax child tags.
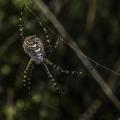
<box><xmin>19</xmin><ymin>6</ymin><xmax>82</xmax><ymax>95</ymax></box>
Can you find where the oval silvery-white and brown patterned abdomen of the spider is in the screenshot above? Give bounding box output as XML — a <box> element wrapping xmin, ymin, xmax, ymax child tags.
<box><xmin>23</xmin><ymin>35</ymin><xmax>45</xmax><ymax>64</ymax></box>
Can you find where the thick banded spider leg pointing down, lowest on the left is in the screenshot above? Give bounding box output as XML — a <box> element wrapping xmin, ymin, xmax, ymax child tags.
<box><xmin>23</xmin><ymin>59</ymin><xmax>34</xmax><ymax>96</ymax></box>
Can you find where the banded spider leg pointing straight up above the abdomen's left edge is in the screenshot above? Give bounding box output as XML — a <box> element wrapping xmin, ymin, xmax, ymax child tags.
<box><xmin>19</xmin><ymin>6</ymin><xmax>25</xmax><ymax>40</ymax></box>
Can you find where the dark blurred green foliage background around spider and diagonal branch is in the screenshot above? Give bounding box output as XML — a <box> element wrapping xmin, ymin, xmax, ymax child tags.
<box><xmin>0</xmin><ymin>0</ymin><xmax>120</xmax><ymax>120</ymax></box>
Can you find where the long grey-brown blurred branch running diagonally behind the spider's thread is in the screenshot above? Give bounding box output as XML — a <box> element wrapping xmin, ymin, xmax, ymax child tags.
<box><xmin>35</xmin><ymin>0</ymin><xmax>120</xmax><ymax>111</ymax></box>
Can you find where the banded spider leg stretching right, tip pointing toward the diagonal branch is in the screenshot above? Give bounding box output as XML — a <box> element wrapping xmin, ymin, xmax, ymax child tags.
<box><xmin>44</xmin><ymin>58</ymin><xmax>82</xmax><ymax>75</ymax></box>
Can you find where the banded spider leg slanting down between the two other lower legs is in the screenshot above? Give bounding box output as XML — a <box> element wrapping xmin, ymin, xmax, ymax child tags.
<box><xmin>43</xmin><ymin>63</ymin><xmax>63</xmax><ymax>94</ymax></box>
